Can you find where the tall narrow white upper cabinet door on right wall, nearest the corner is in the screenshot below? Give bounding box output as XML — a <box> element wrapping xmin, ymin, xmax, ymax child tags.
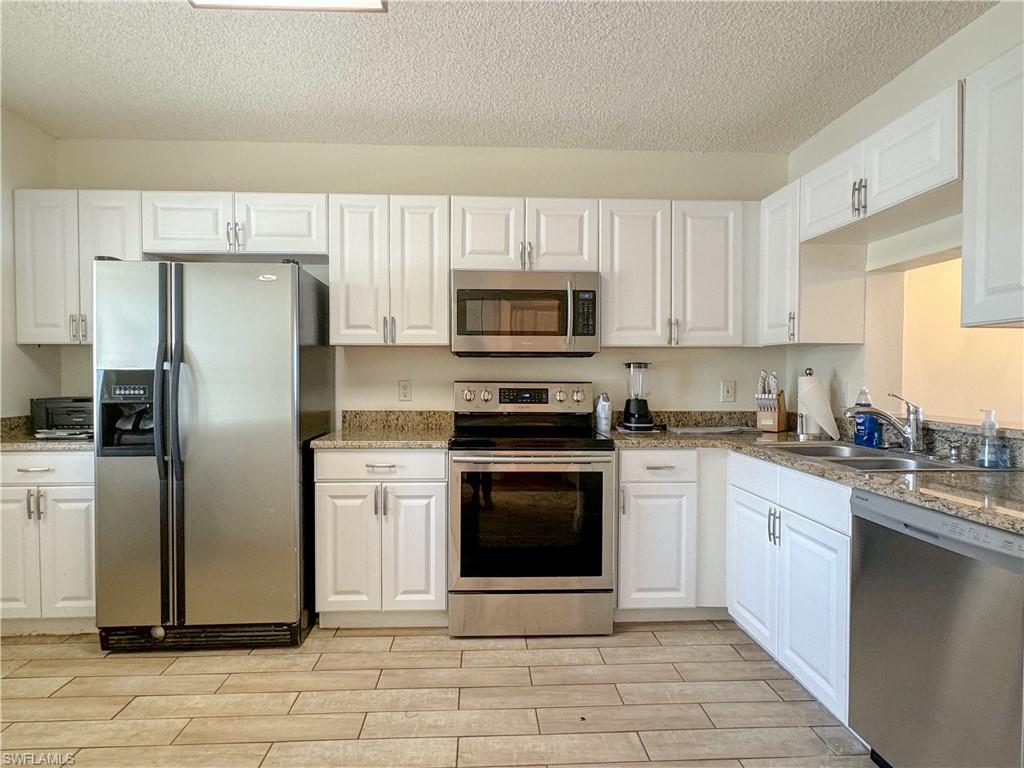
<box><xmin>758</xmin><ymin>181</ymin><xmax>801</xmax><ymax>345</ymax></box>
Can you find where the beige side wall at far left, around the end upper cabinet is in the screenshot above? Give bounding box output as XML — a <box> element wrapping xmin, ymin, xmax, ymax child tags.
<box><xmin>0</xmin><ymin>110</ymin><xmax>60</xmax><ymax>416</ymax></box>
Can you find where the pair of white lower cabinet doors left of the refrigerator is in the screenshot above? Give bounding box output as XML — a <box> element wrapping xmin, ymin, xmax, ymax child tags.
<box><xmin>0</xmin><ymin>485</ymin><xmax>96</xmax><ymax>618</ymax></box>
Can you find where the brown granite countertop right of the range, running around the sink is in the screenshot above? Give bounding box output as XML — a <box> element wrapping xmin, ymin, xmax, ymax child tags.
<box><xmin>612</xmin><ymin>432</ymin><xmax>1024</xmax><ymax>535</ymax></box>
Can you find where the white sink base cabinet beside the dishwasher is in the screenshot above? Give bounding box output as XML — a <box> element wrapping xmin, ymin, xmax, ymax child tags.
<box><xmin>726</xmin><ymin>456</ymin><xmax>850</xmax><ymax>723</ymax></box>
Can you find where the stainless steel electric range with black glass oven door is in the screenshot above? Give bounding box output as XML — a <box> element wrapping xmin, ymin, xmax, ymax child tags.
<box><xmin>449</xmin><ymin>382</ymin><xmax>615</xmax><ymax>636</ymax></box>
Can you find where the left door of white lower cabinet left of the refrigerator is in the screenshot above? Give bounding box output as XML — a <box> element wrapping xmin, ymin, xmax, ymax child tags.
<box><xmin>0</xmin><ymin>486</ymin><xmax>40</xmax><ymax>618</ymax></box>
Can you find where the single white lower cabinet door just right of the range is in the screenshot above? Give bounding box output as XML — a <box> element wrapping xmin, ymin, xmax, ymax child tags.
<box><xmin>618</xmin><ymin>482</ymin><xmax>697</xmax><ymax>608</ymax></box>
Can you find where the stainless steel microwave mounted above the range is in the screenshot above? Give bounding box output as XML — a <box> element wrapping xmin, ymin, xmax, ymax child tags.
<box><xmin>452</xmin><ymin>270</ymin><xmax>601</xmax><ymax>357</ymax></box>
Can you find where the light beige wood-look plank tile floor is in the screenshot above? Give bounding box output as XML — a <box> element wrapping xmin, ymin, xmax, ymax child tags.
<box><xmin>0</xmin><ymin>622</ymin><xmax>872</xmax><ymax>768</ymax></box>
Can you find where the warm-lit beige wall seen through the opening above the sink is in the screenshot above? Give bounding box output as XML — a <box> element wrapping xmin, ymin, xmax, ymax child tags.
<box><xmin>903</xmin><ymin>259</ymin><xmax>1024</xmax><ymax>427</ymax></box>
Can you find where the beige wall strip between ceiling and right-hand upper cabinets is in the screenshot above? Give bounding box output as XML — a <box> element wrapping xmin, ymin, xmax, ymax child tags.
<box><xmin>790</xmin><ymin>0</ymin><xmax>1024</xmax><ymax>179</ymax></box>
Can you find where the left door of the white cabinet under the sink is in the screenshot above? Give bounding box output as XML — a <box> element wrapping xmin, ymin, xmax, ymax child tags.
<box><xmin>726</xmin><ymin>486</ymin><xmax>778</xmax><ymax>653</ymax></box>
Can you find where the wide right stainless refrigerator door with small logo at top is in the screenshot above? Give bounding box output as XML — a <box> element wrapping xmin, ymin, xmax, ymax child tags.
<box><xmin>171</xmin><ymin>263</ymin><xmax>300</xmax><ymax>625</ymax></box>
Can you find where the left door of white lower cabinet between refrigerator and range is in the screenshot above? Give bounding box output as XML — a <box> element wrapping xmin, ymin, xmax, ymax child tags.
<box><xmin>315</xmin><ymin>483</ymin><xmax>381</xmax><ymax>611</ymax></box>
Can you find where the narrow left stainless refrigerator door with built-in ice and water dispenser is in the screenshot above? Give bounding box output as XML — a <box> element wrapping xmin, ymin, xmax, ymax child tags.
<box><xmin>93</xmin><ymin>261</ymin><xmax>171</xmax><ymax>628</ymax></box>
